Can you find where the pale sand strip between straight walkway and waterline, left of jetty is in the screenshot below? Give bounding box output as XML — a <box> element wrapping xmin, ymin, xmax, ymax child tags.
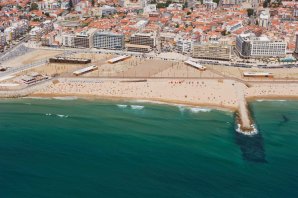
<box><xmin>33</xmin><ymin>78</ymin><xmax>238</xmax><ymax>110</ymax></box>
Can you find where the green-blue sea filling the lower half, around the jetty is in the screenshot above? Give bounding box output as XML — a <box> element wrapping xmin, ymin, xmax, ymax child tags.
<box><xmin>0</xmin><ymin>98</ymin><xmax>298</xmax><ymax>198</ymax></box>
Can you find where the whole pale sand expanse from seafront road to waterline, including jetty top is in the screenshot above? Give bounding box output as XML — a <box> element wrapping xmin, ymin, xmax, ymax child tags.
<box><xmin>2</xmin><ymin>50</ymin><xmax>298</xmax><ymax>131</ymax></box>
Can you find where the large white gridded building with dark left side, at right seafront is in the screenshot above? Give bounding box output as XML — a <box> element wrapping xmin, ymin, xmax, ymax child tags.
<box><xmin>236</xmin><ymin>33</ymin><xmax>287</xmax><ymax>58</ymax></box>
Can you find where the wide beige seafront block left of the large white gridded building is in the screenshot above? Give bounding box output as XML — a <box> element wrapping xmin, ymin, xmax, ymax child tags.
<box><xmin>192</xmin><ymin>43</ymin><xmax>232</xmax><ymax>61</ymax></box>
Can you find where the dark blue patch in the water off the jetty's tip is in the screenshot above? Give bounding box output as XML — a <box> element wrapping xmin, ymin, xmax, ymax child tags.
<box><xmin>235</xmin><ymin>131</ymin><xmax>267</xmax><ymax>163</ymax></box>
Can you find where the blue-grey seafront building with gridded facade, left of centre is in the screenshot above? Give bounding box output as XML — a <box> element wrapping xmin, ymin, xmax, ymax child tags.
<box><xmin>93</xmin><ymin>32</ymin><xmax>124</xmax><ymax>50</ymax></box>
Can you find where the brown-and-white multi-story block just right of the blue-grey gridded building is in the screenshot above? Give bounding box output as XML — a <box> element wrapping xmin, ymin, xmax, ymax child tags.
<box><xmin>130</xmin><ymin>32</ymin><xmax>156</xmax><ymax>48</ymax></box>
